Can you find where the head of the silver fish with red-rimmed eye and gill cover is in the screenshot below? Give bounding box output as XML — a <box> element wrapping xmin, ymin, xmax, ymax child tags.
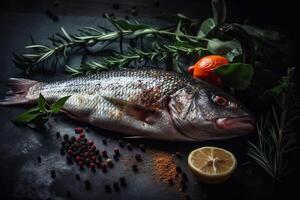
<box><xmin>168</xmin><ymin>80</ymin><xmax>255</xmax><ymax>141</ymax></box>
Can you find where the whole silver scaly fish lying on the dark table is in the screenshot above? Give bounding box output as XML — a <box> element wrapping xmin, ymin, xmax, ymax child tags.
<box><xmin>2</xmin><ymin>69</ymin><xmax>253</xmax><ymax>141</ymax></box>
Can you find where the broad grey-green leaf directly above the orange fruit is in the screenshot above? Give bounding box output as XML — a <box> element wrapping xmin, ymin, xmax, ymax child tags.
<box><xmin>207</xmin><ymin>38</ymin><xmax>242</xmax><ymax>62</ymax></box>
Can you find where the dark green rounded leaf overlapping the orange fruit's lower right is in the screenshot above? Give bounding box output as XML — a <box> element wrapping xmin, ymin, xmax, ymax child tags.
<box><xmin>215</xmin><ymin>63</ymin><xmax>254</xmax><ymax>90</ymax></box>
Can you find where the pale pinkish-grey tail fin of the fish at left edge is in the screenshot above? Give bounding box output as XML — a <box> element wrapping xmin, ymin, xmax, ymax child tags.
<box><xmin>0</xmin><ymin>78</ymin><xmax>38</xmax><ymax>106</ymax></box>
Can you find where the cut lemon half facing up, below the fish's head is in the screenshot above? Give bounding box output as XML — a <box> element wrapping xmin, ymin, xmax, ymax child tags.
<box><xmin>188</xmin><ymin>147</ymin><xmax>237</xmax><ymax>183</ymax></box>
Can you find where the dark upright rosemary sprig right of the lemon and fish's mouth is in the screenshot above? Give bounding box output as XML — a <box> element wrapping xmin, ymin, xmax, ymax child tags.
<box><xmin>248</xmin><ymin>69</ymin><xmax>298</xmax><ymax>182</ymax></box>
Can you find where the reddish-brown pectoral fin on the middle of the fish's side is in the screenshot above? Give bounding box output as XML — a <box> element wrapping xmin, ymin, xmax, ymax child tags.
<box><xmin>104</xmin><ymin>97</ymin><xmax>160</xmax><ymax>124</ymax></box>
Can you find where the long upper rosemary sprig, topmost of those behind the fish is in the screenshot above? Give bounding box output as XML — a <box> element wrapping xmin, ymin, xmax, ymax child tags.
<box><xmin>14</xmin><ymin>17</ymin><xmax>209</xmax><ymax>73</ymax></box>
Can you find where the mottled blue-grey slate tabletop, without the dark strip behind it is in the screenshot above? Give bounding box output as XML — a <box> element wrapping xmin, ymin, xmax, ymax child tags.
<box><xmin>0</xmin><ymin>1</ymin><xmax>298</xmax><ymax>199</ymax></box>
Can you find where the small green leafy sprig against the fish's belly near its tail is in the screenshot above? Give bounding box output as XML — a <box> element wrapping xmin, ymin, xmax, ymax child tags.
<box><xmin>13</xmin><ymin>94</ymin><xmax>70</xmax><ymax>124</ymax></box>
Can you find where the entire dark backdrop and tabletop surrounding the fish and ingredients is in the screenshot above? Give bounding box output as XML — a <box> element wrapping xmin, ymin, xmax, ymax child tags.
<box><xmin>0</xmin><ymin>0</ymin><xmax>299</xmax><ymax>199</ymax></box>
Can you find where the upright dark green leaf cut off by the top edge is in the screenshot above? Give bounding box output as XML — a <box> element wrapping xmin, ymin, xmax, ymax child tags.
<box><xmin>211</xmin><ymin>0</ymin><xmax>226</xmax><ymax>25</ymax></box>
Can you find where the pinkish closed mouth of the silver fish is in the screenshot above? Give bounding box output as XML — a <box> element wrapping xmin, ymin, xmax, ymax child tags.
<box><xmin>215</xmin><ymin>116</ymin><xmax>255</xmax><ymax>132</ymax></box>
